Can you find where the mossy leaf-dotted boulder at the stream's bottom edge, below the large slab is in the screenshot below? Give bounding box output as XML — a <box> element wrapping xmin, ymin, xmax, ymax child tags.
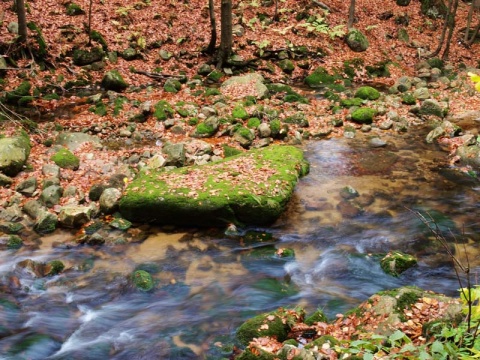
<box><xmin>237</xmin><ymin>309</ymin><xmax>299</xmax><ymax>345</ymax></box>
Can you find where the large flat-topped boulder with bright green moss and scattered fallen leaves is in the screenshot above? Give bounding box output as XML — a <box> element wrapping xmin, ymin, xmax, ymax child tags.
<box><xmin>120</xmin><ymin>146</ymin><xmax>308</xmax><ymax>226</ymax></box>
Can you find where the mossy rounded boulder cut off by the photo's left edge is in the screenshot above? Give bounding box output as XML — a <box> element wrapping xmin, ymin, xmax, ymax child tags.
<box><xmin>0</xmin><ymin>132</ymin><xmax>31</xmax><ymax>176</ymax></box>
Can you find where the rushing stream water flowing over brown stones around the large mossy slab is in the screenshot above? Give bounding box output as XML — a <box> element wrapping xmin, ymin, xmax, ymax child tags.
<box><xmin>0</xmin><ymin>129</ymin><xmax>480</xmax><ymax>360</ymax></box>
